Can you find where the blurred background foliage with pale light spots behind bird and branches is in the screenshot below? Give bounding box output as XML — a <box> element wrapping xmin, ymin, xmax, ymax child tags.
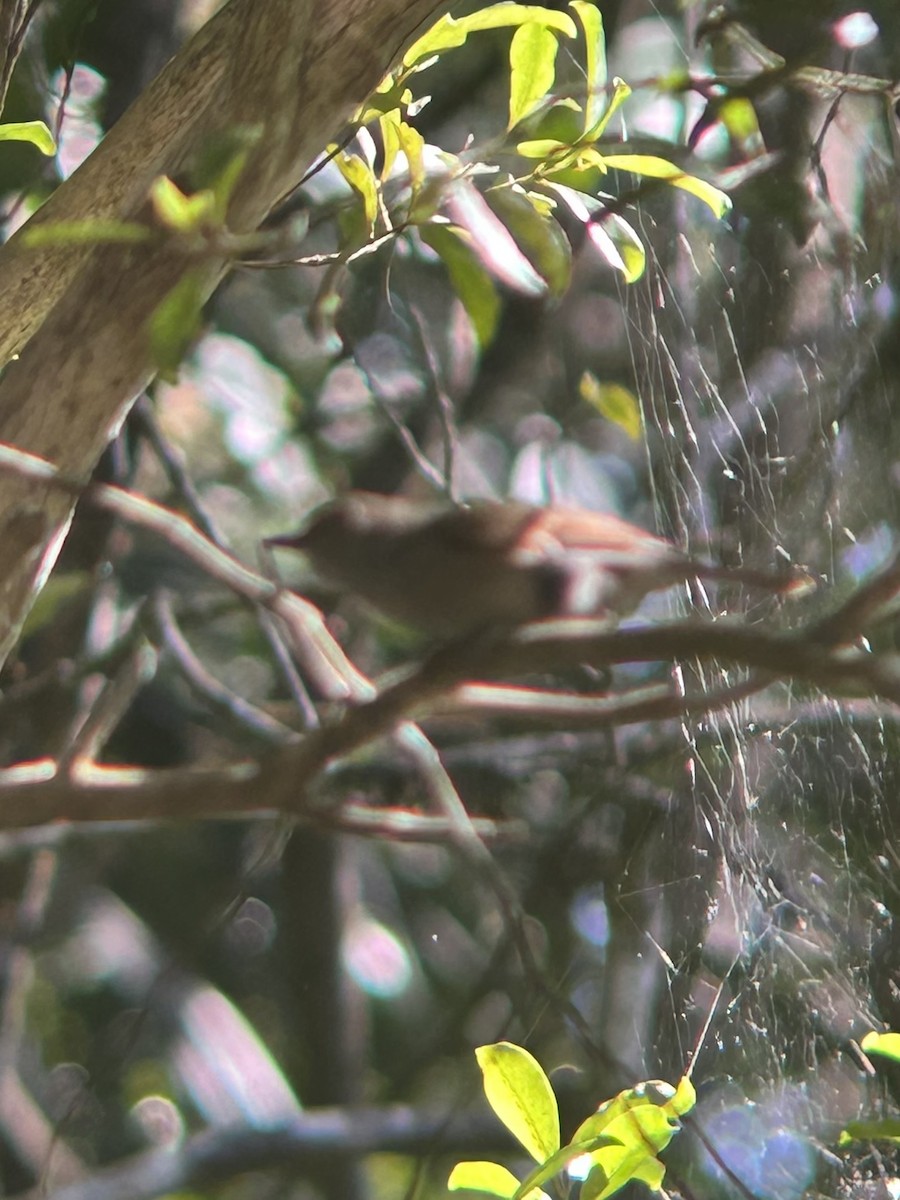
<box><xmin>0</xmin><ymin>0</ymin><xmax>900</xmax><ymax>1200</ymax></box>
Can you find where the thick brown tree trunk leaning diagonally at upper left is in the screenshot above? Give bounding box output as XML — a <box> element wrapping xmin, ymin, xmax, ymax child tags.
<box><xmin>0</xmin><ymin>0</ymin><xmax>445</xmax><ymax>664</ymax></box>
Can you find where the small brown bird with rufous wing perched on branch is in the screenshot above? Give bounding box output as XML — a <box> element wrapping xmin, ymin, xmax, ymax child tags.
<box><xmin>265</xmin><ymin>492</ymin><xmax>798</xmax><ymax>637</ymax></box>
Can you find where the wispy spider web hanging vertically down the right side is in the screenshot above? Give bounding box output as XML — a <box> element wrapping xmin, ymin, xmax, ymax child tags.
<box><xmin>619</xmin><ymin>126</ymin><xmax>900</xmax><ymax>1198</ymax></box>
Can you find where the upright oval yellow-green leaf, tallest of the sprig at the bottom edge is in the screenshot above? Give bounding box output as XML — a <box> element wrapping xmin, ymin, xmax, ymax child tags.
<box><xmin>475</xmin><ymin>1042</ymin><xmax>559</xmax><ymax>1163</ymax></box>
